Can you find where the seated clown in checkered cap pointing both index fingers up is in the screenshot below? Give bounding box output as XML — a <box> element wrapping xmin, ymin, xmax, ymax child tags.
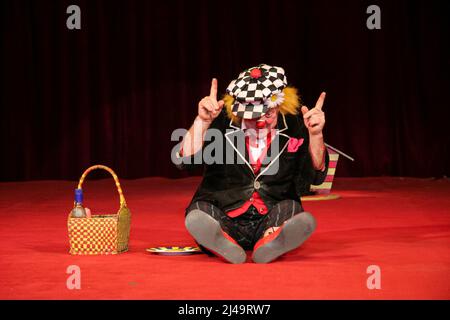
<box><xmin>177</xmin><ymin>64</ymin><xmax>329</xmax><ymax>263</ymax></box>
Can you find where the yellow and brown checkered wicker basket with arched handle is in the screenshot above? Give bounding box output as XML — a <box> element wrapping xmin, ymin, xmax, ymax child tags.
<box><xmin>67</xmin><ymin>165</ymin><xmax>131</xmax><ymax>255</ymax></box>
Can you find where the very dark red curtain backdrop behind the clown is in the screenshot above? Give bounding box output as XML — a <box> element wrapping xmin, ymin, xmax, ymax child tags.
<box><xmin>0</xmin><ymin>0</ymin><xmax>450</xmax><ymax>181</ymax></box>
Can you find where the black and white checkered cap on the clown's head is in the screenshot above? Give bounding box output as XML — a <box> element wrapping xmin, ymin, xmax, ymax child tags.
<box><xmin>227</xmin><ymin>64</ymin><xmax>287</xmax><ymax>119</ymax></box>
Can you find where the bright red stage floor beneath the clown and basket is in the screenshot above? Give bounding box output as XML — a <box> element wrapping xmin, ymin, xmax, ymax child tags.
<box><xmin>0</xmin><ymin>178</ymin><xmax>450</xmax><ymax>299</ymax></box>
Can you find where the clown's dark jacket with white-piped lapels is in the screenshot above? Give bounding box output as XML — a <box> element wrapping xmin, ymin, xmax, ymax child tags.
<box><xmin>177</xmin><ymin>110</ymin><xmax>329</xmax><ymax>212</ymax></box>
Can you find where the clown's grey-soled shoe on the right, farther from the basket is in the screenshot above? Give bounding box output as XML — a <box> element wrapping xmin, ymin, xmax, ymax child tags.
<box><xmin>252</xmin><ymin>212</ymin><xmax>316</xmax><ymax>263</ymax></box>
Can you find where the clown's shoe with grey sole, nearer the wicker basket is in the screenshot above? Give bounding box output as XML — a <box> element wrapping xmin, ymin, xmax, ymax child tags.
<box><xmin>185</xmin><ymin>209</ymin><xmax>247</xmax><ymax>264</ymax></box>
